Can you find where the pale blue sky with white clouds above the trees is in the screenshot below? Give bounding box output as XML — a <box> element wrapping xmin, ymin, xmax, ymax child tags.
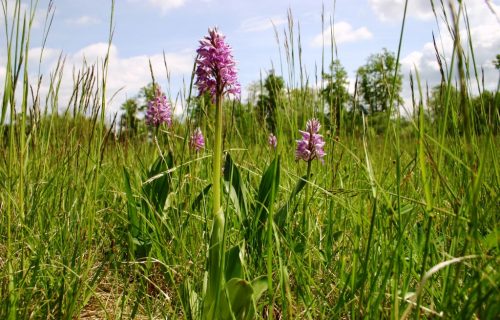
<box><xmin>0</xmin><ymin>0</ymin><xmax>500</xmax><ymax>117</ymax></box>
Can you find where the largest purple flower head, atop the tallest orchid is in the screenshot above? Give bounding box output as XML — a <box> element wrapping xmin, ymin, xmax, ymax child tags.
<box><xmin>195</xmin><ymin>28</ymin><xmax>241</xmax><ymax>100</ymax></box>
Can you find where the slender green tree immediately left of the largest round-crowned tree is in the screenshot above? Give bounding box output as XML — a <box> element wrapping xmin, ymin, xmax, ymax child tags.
<box><xmin>321</xmin><ymin>59</ymin><xmax>349</xmax><ymax>132</ymax></box>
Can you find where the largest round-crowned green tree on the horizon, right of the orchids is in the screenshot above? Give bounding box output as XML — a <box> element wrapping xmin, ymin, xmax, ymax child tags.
<box><xmin>357</xmin><ymin>49</ymin><xmax>403</xmax><ymax>114</ymax></box>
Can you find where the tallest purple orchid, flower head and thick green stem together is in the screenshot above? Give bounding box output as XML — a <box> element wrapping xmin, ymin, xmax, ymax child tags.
<box><xmin>195</xmin><ymin>28</ymin><xmax>241</xmax><ymax>319</ymax></box>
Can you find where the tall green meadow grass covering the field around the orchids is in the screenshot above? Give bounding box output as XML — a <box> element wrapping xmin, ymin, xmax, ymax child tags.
<box><xmin>0</xmin><ymin>1</ymin><xmax>500</xmax><ymax>319</ymax></box>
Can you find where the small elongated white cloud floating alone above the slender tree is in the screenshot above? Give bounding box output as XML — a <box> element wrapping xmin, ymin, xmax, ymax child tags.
<box><xmin>311</xmin><ymin>21</ymin><xmax>373</xmax><ymax>47</ymax></box>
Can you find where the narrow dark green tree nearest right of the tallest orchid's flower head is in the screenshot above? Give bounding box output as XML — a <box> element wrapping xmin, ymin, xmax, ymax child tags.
<box><xmin>257</xmin><ymin>70</ymin><xmax>285</xmax><ymax>132</ymax></box>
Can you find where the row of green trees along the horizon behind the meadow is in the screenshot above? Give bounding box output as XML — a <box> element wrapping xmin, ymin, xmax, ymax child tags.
<box><xmin>120</xmin><ymin>49</ymin><xmax>500</xmax><ymax>136</ymax></box>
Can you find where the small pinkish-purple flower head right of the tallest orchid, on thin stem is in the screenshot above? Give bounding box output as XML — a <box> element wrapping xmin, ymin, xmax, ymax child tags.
<box><xmin>295</xmin><ymin>118</ymin><xmax>326</xmax><ymax>162</ymax></box>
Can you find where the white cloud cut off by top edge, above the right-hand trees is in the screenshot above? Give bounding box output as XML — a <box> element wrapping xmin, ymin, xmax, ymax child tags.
<box><xmin>368</xmin><ymin>0</ymin><xmax>434</xmax><ymax>21</ymax></box>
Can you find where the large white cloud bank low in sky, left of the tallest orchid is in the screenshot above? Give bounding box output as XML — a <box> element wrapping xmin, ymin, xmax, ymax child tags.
<box><xmin>23</xmin><ymin>43</ymin><xmax>194</xmax><ymax>117</ymax></box>
